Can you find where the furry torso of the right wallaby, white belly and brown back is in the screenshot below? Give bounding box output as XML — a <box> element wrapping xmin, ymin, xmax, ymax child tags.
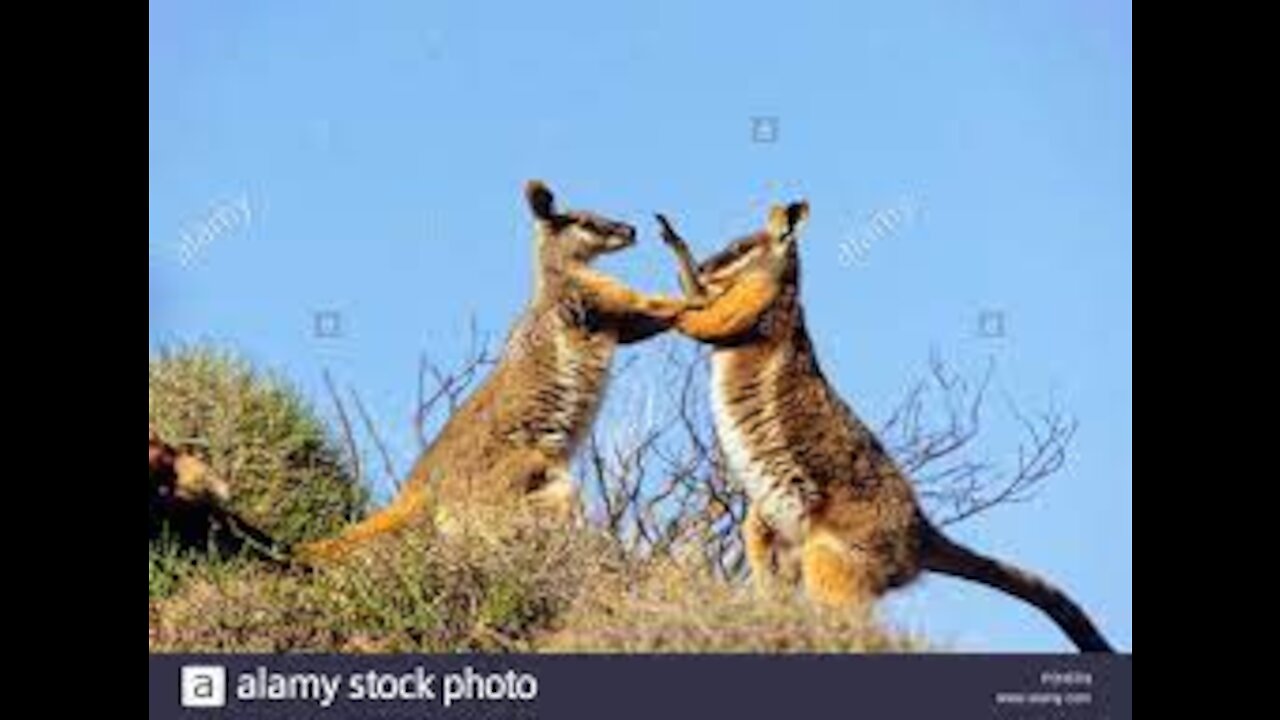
<box><xmin>710</xmin><ymin>283</ymin><xmax>919</xmax><ymax>589</ymax></box>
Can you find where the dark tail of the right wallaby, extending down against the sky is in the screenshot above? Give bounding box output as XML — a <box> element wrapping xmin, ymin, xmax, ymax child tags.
<box><xmin>920</xmin><ymin>527</ymin><xmax>1115</xmax><ymax>652</ymax></box>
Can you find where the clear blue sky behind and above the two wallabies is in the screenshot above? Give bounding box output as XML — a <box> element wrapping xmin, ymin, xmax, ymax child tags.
<box><xmin>147</xmin><ymin>0</ymin><xmax>1133</xmax><ymax>651</ymax></box>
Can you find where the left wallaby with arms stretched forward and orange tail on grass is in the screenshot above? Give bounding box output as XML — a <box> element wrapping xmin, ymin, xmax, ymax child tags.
<box><xmin>296</xmin><ymin>181</ymin><xmax>687</xmax><ymax>560</ymax></box>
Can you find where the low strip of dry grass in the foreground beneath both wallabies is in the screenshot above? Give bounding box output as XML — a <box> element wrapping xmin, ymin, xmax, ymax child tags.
<box><xmin>148</xmin><ymin>507</ymin><xmax>924</xmax><ymax>652</ymax></box>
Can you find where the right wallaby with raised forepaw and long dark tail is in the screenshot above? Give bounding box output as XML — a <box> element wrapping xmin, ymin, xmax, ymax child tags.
<box><xmin>657</xmin><ymin>202</ymin><xmax>1111</xmax><ymax>652</ymax></box>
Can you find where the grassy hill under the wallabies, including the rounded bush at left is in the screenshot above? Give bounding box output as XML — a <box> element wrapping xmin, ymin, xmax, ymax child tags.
<box><xmin>147</xmin><ymin>348</ymin><xmax>924</xmax><ymax>652</ymax></box>
